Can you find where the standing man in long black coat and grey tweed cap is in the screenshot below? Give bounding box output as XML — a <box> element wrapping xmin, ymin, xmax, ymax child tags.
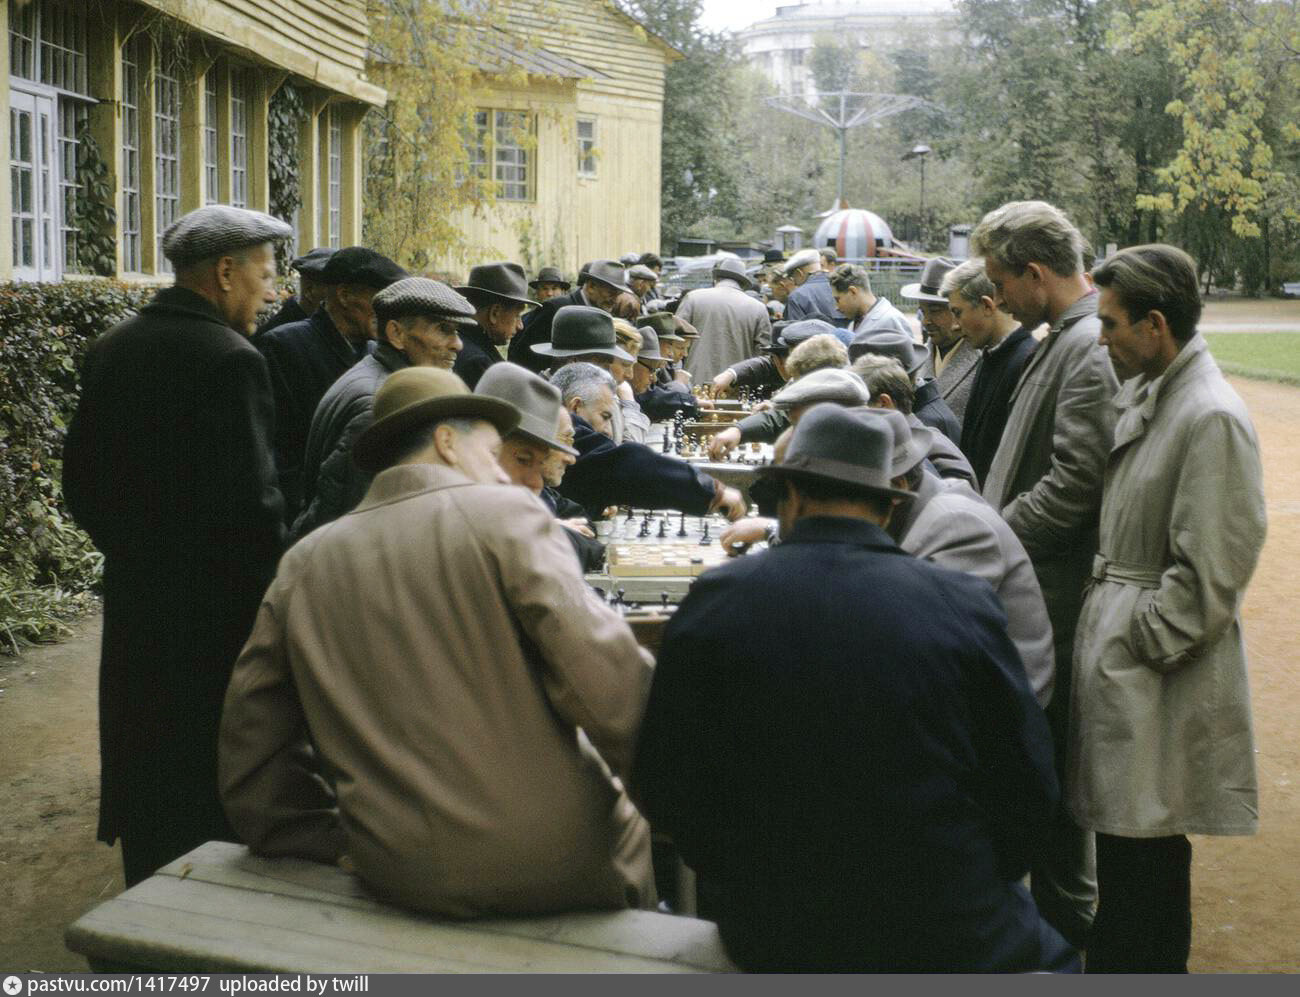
<box><xmin>62</xmin><ymin>205</ymin><xmax>291</xmax><ymax>887</ymax></box>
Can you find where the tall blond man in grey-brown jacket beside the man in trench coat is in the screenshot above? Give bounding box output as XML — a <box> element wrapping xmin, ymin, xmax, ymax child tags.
<box><xmin>971</xmin><ymin>201</ymin><xmax>1119</xmax><ymax>948</ymax></box>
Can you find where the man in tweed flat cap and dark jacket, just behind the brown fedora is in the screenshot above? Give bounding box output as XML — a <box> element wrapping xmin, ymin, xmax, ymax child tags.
<box><xmin>293</xmin><ymin>277</ymin><xmax>475</xmax><ymax>539</ymax></box>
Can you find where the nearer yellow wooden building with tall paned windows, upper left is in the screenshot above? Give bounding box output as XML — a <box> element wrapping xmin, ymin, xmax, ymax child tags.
<box><xmin>0</xmin><ymin>0</ymin><xmax>386</xmax><ymax>281</ymax></box>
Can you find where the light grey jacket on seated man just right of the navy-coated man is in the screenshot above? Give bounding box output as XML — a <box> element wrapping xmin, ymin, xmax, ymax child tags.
<box><xmin>889</xmin><ymin>471</ymin><xmax>1056</xmax><ymax>706</ymax></box>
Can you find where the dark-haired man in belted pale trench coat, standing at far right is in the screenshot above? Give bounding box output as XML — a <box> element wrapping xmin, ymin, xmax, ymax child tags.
<box><xmin>1066</xmin><ymin>246</ymin><xmax>1265</xmax><ymax>972</ymax></box>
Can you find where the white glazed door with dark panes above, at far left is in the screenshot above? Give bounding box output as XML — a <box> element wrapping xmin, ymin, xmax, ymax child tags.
<box><xmin>5</xmin><ymin>0</ymin><xmax>95</xmax><ymax>279</ymax></box>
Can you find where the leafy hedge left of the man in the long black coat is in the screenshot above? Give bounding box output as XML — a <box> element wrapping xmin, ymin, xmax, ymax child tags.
<box><xmin>0</xmin><ymin>281</ymin><xmax>153</xmax><ymax>653</ymax></box>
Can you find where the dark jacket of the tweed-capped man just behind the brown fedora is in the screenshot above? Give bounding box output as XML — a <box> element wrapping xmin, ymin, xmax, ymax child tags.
<box><xmin>293</xmin><ymin>342</ymin><xmax>411</xmax><ymax>541</ymax></box>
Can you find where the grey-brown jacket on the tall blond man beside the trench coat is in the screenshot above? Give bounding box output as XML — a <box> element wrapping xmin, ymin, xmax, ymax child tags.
<box><xmin>984</xmin><ymin>291</ymin><xmax>1119</xmax><ymax>681</ymax></box>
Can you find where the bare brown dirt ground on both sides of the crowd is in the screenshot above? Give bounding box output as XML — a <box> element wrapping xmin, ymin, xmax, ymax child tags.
<box><xmin>0</xmin><ymin>381</ymin><xmax>1300</xmax><ymax>972</ymax></box>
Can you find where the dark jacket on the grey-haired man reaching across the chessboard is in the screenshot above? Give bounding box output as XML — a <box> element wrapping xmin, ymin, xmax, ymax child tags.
<box><xmin>553</xmin><ymin>415</ymin><xmax>715</xmax><ymax>519</ymax></box>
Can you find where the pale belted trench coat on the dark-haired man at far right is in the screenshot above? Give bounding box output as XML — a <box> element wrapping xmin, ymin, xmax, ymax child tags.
<box><xmin>1066</xmin><ymin>334</ymin><xmax>1265</xmax><ymax>837</ymax></box>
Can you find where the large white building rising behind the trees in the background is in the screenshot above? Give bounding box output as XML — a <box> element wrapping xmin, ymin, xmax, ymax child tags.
<box><xmin>736</xmin><ymin>0</ymin><xmax>958</xmax><ymax>94</ymax></box>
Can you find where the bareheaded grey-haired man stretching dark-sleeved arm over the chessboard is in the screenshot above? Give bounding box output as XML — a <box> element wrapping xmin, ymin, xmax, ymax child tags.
<box><xmin>551</xmin><ymin>363</ymin><xmax>745</xmax><ymax>520</ymax></box>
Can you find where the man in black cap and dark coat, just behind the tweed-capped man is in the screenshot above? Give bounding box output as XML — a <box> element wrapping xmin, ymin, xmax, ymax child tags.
<box><xmin>255</xmin><ymin>246</ymin><xmax>407</xmax><ymax>523</ymax></box>
